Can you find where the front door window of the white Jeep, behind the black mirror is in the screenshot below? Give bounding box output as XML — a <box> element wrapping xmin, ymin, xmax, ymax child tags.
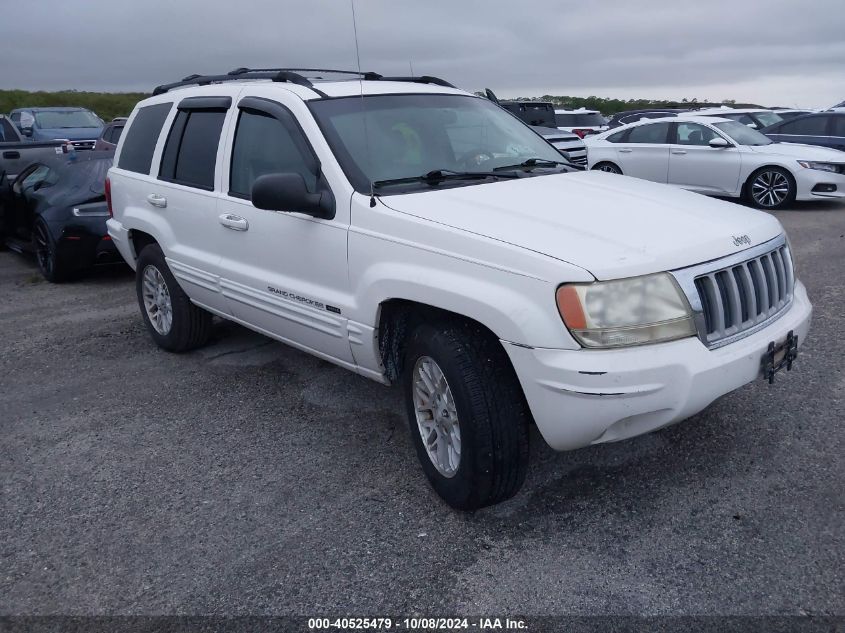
<box><xmin>229</xmin><ymin>111</ymin><xmax>317</xmax><ymax>198</ymax></box>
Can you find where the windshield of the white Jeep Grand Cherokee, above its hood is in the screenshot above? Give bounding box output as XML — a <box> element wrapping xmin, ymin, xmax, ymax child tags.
<box><xmin>308</xmin><ymin>94</ymin><xmax>562</xmax><ymax>193</ymax></box>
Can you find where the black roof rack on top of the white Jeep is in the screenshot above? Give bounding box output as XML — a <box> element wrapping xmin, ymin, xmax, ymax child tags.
<box><xmin>153</xmin><ymin>68</ymin><xmax>455</xmax><ymax>97</ymax></box>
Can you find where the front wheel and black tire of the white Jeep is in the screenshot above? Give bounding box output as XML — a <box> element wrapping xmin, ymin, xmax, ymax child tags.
<box><xmin>401</xmin><ymin>322</ymin><xmax>530</xmax><ymax>510</ymax></box>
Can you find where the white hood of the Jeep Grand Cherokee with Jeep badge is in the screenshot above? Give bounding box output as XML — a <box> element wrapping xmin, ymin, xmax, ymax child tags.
<box><xmin>381</xmin><ymin>171</ymin><xmax>783</xmax><ymax>279</ymax></box>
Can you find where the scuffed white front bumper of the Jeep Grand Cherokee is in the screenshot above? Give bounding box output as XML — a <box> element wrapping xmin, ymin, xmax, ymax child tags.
<box><xmin>503</xmin><ymin>282</ymin><xmax>812</xmax><ymax>450</ymax></box>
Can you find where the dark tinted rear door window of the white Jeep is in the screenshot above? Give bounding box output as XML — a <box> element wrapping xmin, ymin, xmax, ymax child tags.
<box><xmin>160</xmin><ymin>110</ymin><xmax>226</xmax><ymax>190</ymax></box>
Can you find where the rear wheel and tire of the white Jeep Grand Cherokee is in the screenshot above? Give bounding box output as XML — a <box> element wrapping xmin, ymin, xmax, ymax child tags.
<box><xmin>135</xmin><ymin>244</ymin><xmax>212</xmax><ymax>352</ymax></box>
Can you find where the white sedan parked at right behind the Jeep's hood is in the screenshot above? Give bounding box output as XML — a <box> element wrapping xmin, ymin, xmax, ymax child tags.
<box><xmin>584</xmin><ymin>115</ymin><xmax>845</xmax><ymax>209</ymax></box>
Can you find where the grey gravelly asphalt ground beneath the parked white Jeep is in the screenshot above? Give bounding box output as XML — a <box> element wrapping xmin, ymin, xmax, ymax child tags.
<box><xmin>0</xmin><ymin>198</ymin><xmax>845</xmax><ymax>616</ymax></box>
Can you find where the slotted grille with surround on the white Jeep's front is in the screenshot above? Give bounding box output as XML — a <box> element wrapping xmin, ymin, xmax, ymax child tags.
<box><xmin>673</xmin><ymin>236</ymin><xmax>795</xmax><ymax>347</ymax></box>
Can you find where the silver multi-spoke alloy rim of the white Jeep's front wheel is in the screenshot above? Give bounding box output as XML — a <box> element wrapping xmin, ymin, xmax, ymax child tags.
<box><xmin>413</xmin><ymin>356</ymin><xmax>461</xmax><ymax>478</ymax></box>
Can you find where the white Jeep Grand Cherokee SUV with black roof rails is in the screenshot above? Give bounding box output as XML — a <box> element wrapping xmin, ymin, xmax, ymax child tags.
<box><xmin>107</xmin><ymin>69</ymin><xmax>811</xmax><ymax>509</ymax></box>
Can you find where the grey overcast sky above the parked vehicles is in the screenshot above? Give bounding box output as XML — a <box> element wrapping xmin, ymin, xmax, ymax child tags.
<box><xmin>0</xmin><ymin>0</ymin><xmax>845</xmax><ymax>107</ymax></box>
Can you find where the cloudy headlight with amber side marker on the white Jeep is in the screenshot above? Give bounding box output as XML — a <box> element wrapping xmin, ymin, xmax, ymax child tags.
<box><xmin>557</xmin><ymin>273</ymin><xmax>695</xmax><ymax>347</ymax></box>
